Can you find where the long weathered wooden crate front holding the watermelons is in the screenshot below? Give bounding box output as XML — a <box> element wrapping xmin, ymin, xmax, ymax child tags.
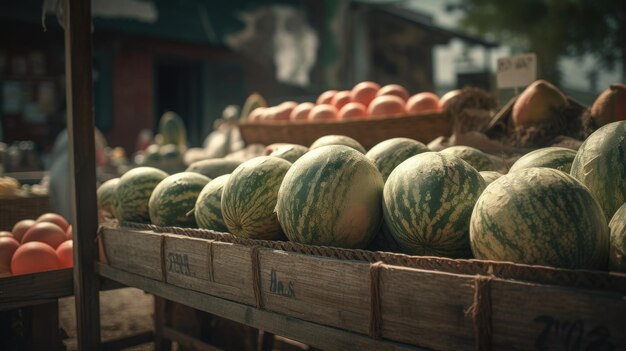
<box><xmin>99</xmin><ymin>223</ymin><xmax>626</xmax><ymax>350</ymax></box>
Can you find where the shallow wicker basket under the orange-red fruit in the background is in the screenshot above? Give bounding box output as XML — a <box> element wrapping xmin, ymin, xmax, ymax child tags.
<box><xmin>239</xmin><ymin>113</ymin><xmax>452</xmax><ymax>149</ymax></box>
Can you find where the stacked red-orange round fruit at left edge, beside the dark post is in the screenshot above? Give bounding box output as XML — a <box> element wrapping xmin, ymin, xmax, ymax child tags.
<box><xmin>0</xmin><ymin>213</ymin><xmax>74</xmax><ymax>275</ymax></box>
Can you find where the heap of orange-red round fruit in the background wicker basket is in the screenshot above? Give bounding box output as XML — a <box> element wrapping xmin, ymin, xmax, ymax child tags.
<box><xmin>246</xmin><ymin>81</ymin><xmax>457</xmax><ymax>122</ymax></box>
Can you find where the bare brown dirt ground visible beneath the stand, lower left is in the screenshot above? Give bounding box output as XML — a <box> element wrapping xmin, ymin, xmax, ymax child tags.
<box><xmin>59</xmin><ymin>288</ymin><xmax>154</xmax><ymax>351</ymax></box>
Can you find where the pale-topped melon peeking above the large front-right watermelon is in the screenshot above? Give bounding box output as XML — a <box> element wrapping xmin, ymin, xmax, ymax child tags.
<box><xmin>509</xmin><ymin>146</ymin><xmax>576</xmax><ymax>173</ymax></box>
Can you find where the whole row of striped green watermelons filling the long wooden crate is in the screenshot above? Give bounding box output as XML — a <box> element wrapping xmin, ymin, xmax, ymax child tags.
<box><xmin>98</xmin><ymin>121</ymin><xmax>626</xmax><ymax>271</ymax></box>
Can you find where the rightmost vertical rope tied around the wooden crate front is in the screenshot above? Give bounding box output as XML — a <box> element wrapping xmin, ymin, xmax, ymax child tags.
<box><xmin>465</xmin><ymin>275</ymin><xmax>493</xmax><ymax>351</ymax></box>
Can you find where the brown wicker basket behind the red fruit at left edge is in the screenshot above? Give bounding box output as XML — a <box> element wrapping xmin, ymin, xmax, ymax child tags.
<box><xmin>0</xmin><ymin>196</ymin><xmax>52</xmax><ymax>231</ymax></box>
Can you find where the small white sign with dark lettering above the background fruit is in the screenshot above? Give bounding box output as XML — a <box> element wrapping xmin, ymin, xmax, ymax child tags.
<box><xmin>496</xmin><ymin>54</ymin><xmax>537</xmax><ymax>89</ymax></box>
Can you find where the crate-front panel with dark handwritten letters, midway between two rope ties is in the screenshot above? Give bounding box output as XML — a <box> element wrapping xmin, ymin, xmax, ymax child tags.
<box><xmin>259</xmin><ymin>249</ymin><xmax>370</xmax><ymax>334</ymax></box>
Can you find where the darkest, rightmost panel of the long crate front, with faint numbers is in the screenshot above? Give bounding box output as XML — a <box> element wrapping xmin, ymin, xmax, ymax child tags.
<box><xmin>490</xmin><ymin>280</ymin><xmax>626</xmax><ymax>350</ymax></box>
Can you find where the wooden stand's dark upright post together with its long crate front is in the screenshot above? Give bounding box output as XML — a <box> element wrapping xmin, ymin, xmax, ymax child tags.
<box><xmin>64</xmin><ymin>0</ymin><xmax>626</xmax><ymax>350</ymax></box>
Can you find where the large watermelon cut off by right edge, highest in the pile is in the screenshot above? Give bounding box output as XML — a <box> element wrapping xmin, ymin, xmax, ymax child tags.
<box><xmin>570</xmin><ymin>121</ymin><xmax>626</xmax><ymax>221</ymax></box>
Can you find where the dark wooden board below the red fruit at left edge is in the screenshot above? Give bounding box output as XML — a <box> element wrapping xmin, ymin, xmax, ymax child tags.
<box><xmin>0</xmin><ymin>269</ymin><xmax>74</xmax><ymax>310</ymax></box>
